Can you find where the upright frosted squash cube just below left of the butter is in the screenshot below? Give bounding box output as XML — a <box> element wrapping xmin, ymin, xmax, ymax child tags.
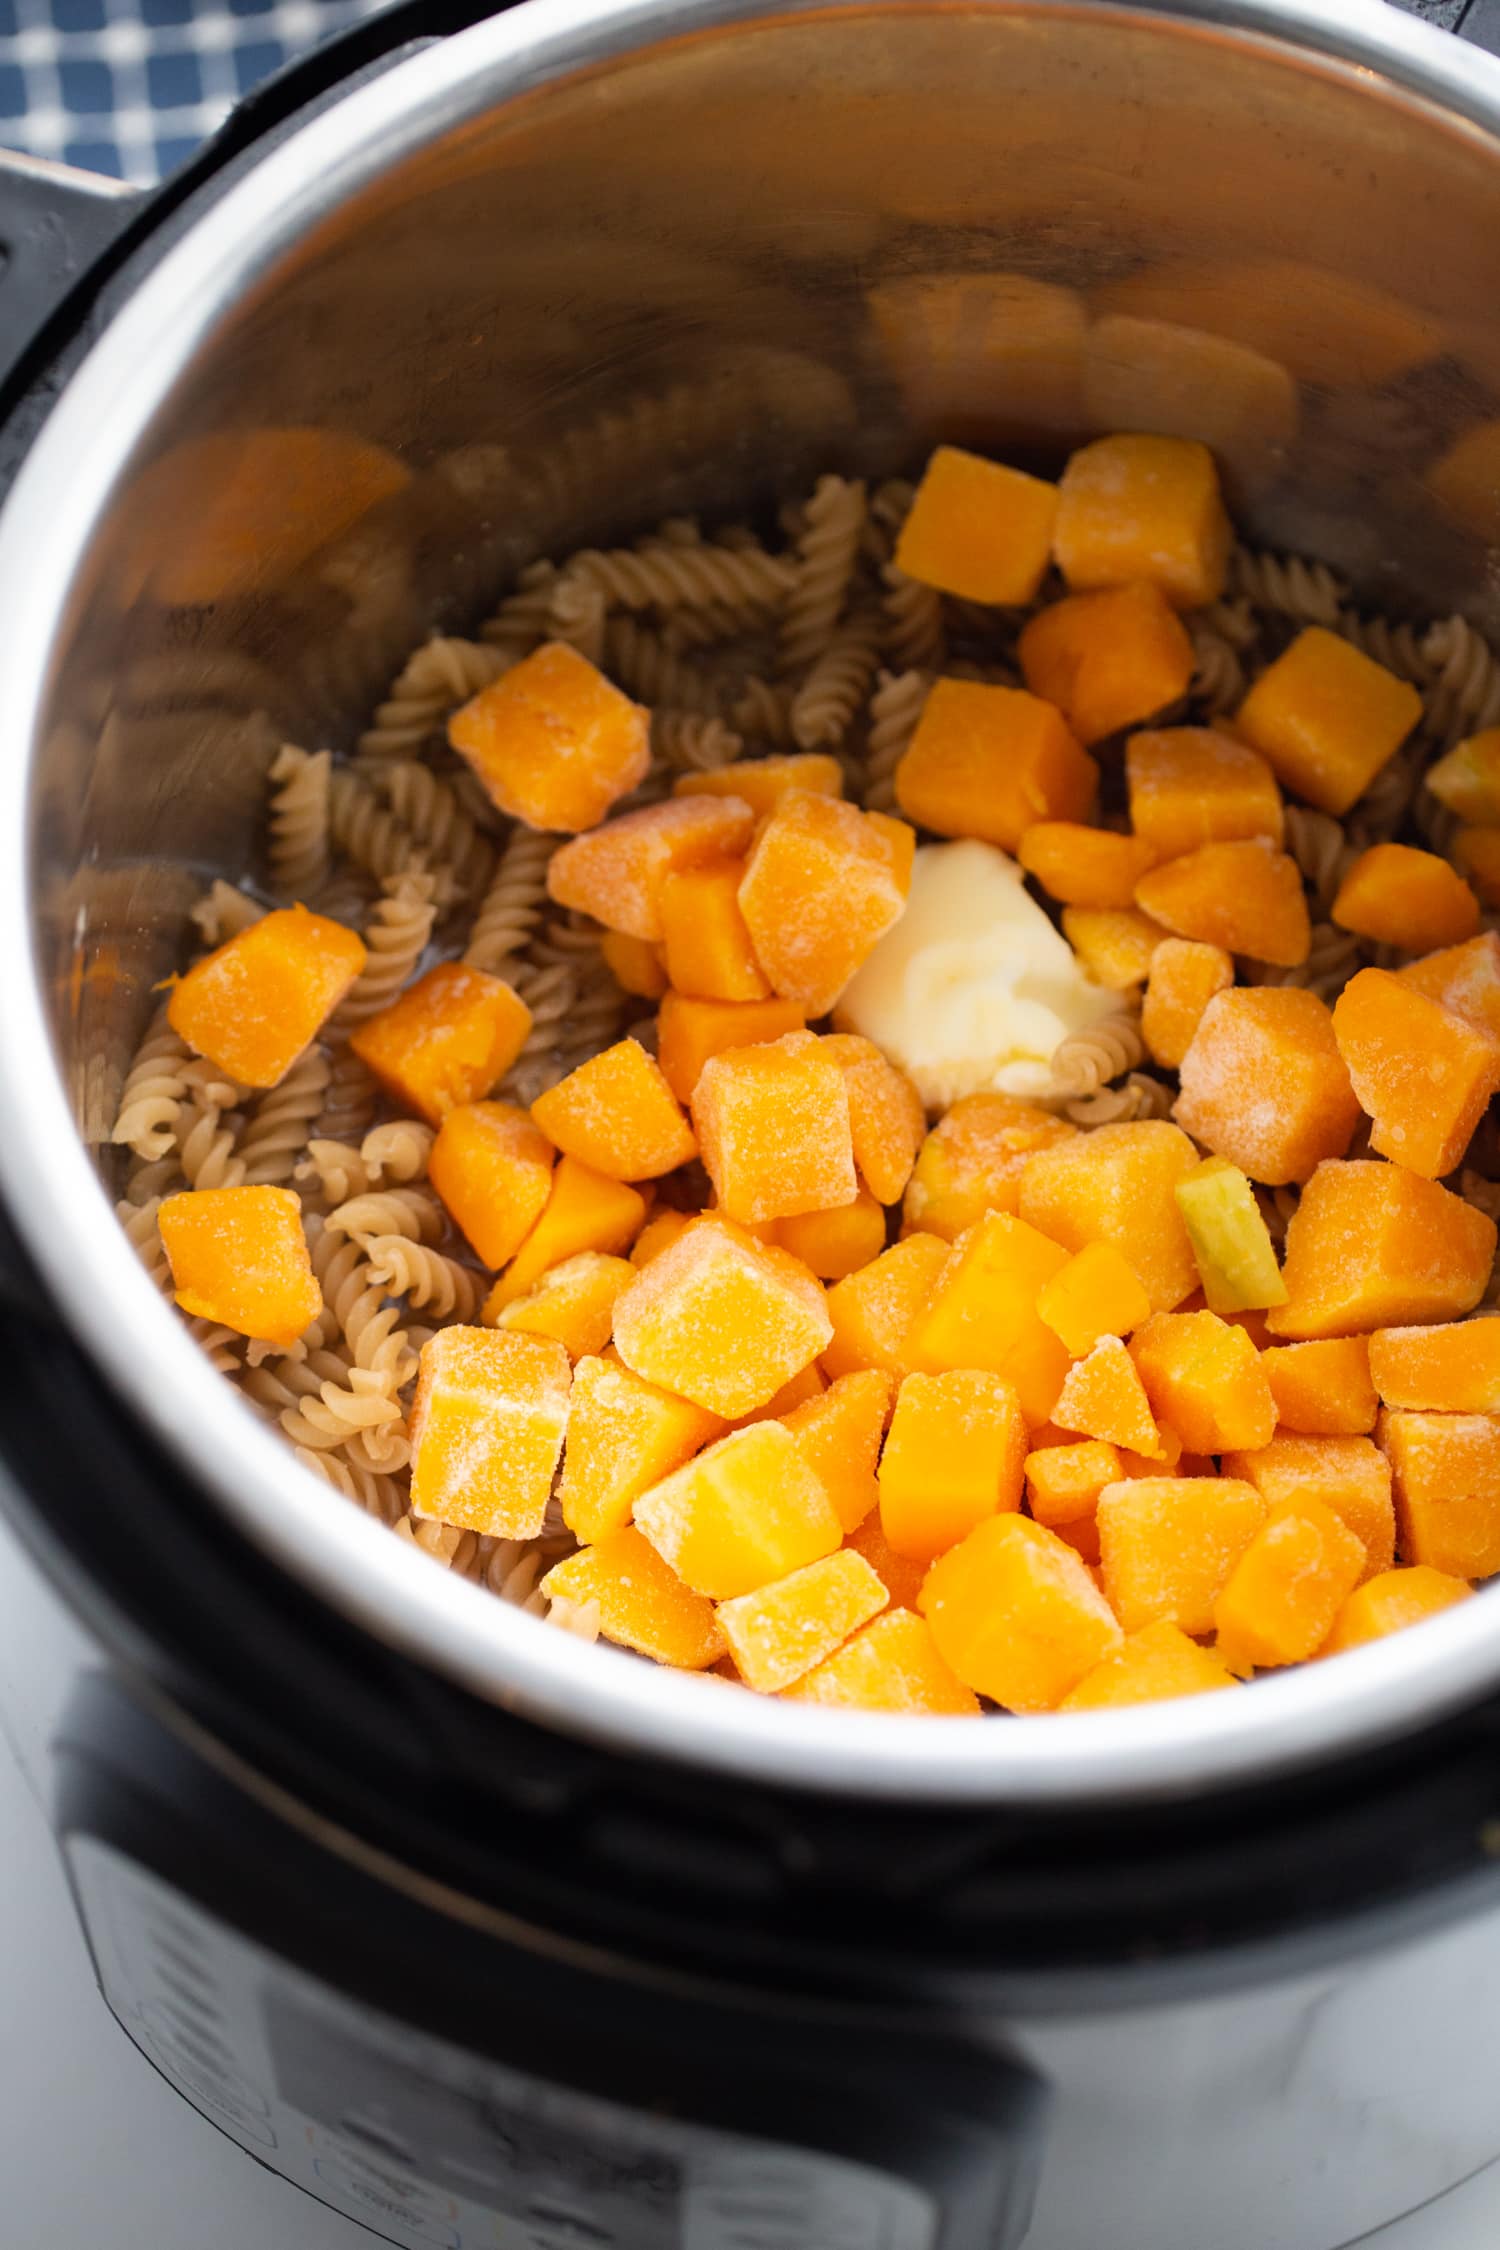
<box><xmin>693</xmin><ymin>1031</ymin><xmax>859</xmax><ymax>1226</ymax></box>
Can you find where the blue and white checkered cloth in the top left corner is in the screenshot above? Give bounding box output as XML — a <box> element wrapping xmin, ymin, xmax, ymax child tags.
<box><xmin>0</xmin><ymin>0</ymin><xmax>387</xmax><ymax>187</ymax></box>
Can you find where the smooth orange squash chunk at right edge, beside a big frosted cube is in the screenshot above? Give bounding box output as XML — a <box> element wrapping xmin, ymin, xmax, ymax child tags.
<box><xmin>1334</xmin><ymin>970</ymin><xmax>1500</xmax><ymax>1179</ymax></box>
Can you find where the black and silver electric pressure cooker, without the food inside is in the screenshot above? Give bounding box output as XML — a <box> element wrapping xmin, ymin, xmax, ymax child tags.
<box><xmin>0</xmin><ymin>0</ymin><xmax>1500</xmax><ymax>2250</ymax></box>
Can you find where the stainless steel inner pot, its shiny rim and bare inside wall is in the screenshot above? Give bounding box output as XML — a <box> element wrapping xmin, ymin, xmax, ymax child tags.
<box><xmin>0</xmin><ymin>0</ymin><xmax>1500</xmax><ymax>1802</ymax></box>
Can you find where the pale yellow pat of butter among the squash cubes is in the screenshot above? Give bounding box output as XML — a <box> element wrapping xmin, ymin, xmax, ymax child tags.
<box><xmin>839</xmin><ymin>842</ymin><xmax>1120</xmax><ymax>1109</ymax></box>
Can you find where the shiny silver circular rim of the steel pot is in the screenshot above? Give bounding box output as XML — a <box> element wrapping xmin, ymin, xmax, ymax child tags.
<box><xmin>0</xmin><ymin>0</ymin><xmax>1500</xmax><ymax>1807</ymax></box>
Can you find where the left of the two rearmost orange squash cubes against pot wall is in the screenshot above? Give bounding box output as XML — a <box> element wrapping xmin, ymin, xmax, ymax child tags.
<box><xmin>895</xmin><ymin>446</ymin><xmax>1057</xmax><ymax>605</ymax></box>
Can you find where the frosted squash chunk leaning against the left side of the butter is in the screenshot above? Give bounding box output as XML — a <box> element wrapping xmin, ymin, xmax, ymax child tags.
<box><xmin>737</xmin><ymin>790</ymin><xmax>915</xmax><ymax>1015</ymax></box>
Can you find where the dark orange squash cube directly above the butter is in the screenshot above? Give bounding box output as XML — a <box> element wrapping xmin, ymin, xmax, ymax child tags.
<box><xmin>895</xmin><ymin>680</ymin><xmax>1100</xmax><ymax>851</ymax></box>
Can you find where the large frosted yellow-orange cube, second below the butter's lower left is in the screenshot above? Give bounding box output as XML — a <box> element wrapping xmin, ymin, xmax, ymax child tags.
<box><xmin>614</xmin><ymin>1217</ymin><xmax>832</xmax><ymax>1422</ymax></box>
